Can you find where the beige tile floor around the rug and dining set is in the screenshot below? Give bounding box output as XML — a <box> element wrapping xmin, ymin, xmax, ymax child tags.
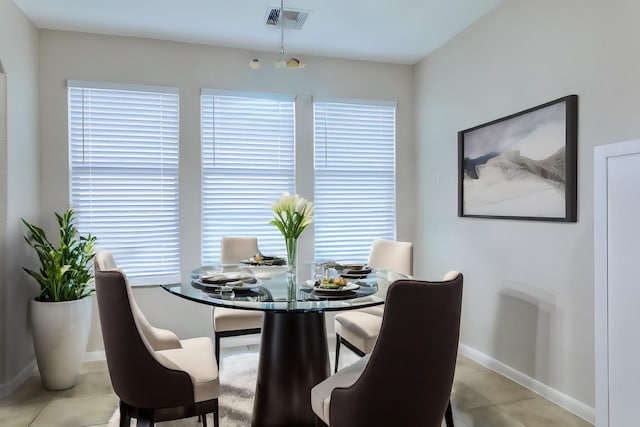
<box><xmin>0</xmin><ymin>342</ymin><xmax>593</xmax><ymax>427</ymax></box>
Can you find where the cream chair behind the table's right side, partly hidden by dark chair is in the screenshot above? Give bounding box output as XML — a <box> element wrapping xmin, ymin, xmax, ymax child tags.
<box><xmin>334</xmin><ymin>239</ymin><xmax>413</xmax><ymax>372</ymax></box>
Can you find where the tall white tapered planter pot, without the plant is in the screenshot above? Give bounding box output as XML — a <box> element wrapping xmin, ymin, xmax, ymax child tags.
<box><xmin>31</xmin><ymin>297</ymin><xmax>92</xmax><ymax>390</ymax></box>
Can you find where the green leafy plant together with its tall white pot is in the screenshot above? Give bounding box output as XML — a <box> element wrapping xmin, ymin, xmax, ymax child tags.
<box><xmin>21</xmin><ymin>209</ymin><xmax>96</xmax><ymax>390</ymax></box>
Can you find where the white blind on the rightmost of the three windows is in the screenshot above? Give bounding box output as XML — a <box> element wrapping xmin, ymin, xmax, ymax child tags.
<box><xmin>313</xmin><ymin>99</ymin><xmax>396</xmax><ymax>261</ymax></box>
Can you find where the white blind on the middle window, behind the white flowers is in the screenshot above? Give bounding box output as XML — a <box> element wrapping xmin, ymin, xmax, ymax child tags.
<box><xmin>201</xmin><ymin>90</ymin><xmax>295</xmax><ymax>264</ymax></box>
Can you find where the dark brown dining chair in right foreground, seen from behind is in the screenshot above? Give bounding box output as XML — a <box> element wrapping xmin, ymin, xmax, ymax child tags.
<box><xmin>311</xmin><ymin>272</ymin><xmax>463</xmax><ymax>427</ymax></box>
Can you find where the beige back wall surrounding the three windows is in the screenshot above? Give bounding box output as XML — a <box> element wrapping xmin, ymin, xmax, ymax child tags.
<box><xmin>40</xmin><ymin>31</ymin><xmax>415</xmax><ymax>350</ymax></box>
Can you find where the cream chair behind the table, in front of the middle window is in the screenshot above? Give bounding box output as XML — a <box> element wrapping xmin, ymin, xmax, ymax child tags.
<box><xmin>211</xmin><ymin>236</ymin><xmax>263</xmax><ymax>360</ymax></box>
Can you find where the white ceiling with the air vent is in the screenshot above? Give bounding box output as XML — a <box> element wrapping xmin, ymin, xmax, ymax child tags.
<box><xmin>14</xmin><ymin>0</ymin><xmax>502</xmax><ymax>64</ymax></box>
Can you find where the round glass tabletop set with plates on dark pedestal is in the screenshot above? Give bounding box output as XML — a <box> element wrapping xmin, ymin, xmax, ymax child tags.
<box><xmin>162</xmin><ymin>266</ymin><xmax>407</xmax><ymax>312</ymax></box>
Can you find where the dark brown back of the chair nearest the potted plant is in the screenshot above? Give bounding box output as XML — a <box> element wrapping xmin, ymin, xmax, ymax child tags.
<box><xmin>95</xmin><ymin>252</ymin><xmax>194</xmax><ymax>408</ymax></box>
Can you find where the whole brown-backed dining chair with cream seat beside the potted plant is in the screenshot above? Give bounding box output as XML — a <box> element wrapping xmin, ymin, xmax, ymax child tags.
<box><xmin>94</xmin><ymin>251</ymin><xmax>220</xmax><ymax>427</ymax></box>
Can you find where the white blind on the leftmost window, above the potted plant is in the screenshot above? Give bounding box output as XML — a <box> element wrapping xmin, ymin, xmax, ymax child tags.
<box><xmin>68</xmin><ymin>81</ymin><xmax>180</xmax><ymax>284</ymax></box>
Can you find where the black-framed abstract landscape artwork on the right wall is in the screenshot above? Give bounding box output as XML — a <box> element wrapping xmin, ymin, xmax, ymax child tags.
<box><xmin>458</xmin><ymin>95</ymin><xmax>578</xmax><ymax>222</ymax></box>
